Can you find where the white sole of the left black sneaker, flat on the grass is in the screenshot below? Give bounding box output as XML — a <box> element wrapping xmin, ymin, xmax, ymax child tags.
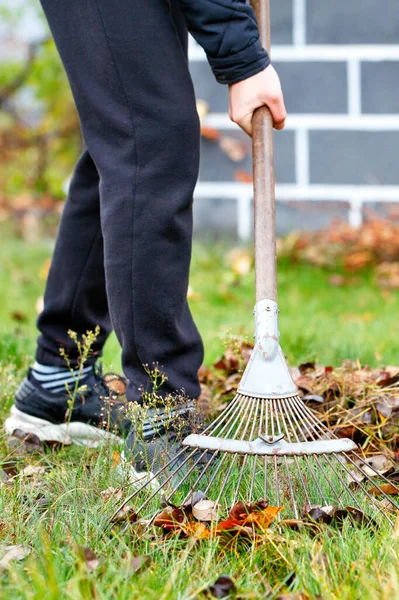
<box><xmin>4</xmin><ymin>405</ymin><xmax>123</xmax><ymax>448</ymax></box>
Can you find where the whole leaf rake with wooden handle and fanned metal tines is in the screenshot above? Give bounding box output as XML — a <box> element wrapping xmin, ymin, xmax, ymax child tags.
<box><xmin>111</xmin><ymin>0</ymin><xmax>399</xmax><ymax>524</ymax></box>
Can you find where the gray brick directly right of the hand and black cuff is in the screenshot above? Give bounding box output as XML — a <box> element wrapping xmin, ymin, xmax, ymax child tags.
<box><xmin>273</xmin><ymin>61</ymin><xmax>348</xmax><ymax>113</ymax></box>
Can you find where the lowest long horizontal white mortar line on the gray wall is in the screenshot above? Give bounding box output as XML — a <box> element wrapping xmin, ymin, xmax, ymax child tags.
<box><xmin>195</xmin><ymin>181</ymin><xmax>399</xmax><ymax>202</ymax></box>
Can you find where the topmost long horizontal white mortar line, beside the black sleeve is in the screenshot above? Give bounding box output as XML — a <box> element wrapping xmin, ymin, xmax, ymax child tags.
<box><xmin>189</xmin><ymin>42</ymin><xmax>399</xmax><ymax>62</ymax></box>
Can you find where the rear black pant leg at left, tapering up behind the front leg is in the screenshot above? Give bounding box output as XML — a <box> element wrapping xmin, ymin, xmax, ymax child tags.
<box><xmin>36</xmin><ymin>150</ymin><xmax>111</xmax><ymax>366</ymax></box>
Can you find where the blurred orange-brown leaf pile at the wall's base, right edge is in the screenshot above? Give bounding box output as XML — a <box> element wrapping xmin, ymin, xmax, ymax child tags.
<box><xmin>278</xmin><ymin>218</ymin><xmax>399</xmax><ymax>289</ymax></box>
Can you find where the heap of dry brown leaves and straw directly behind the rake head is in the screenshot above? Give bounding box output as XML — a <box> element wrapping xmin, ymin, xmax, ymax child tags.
<box><xmin>199</xmin><ymin>340</ymin><xmax>399</xmax><ymax>452</ymax></box>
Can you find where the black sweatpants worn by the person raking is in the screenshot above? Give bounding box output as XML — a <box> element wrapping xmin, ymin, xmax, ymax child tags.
<box><xmin>36</xmin><ymin>0</ymin><xmax>203</xmax><ymax>400</ymax></box>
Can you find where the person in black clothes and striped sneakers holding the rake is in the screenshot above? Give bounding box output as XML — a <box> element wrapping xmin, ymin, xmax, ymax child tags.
<box><xmin>5</xmin><ymin>0</ymin><xmax>286</xmax><ymax>464</ymax></box>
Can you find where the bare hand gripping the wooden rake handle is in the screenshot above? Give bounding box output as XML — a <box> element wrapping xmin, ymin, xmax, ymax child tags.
<box><xmin>229</xmin><ymin>65</ymin><xmax>287</xmax><ymax>135</ymax></box>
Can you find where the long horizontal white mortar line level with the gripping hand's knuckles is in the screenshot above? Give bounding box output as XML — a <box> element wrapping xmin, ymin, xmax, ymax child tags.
<box><xmin>204</xmin><ymin>113</ymin><xmax>399</xmax><ymax>135</ymax></box>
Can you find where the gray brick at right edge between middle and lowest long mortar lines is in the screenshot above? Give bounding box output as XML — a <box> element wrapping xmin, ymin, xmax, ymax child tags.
<box><xmin>309</xmin><ymin>131</ymin><xmax>399</xmax><ymax>185</ymax></box>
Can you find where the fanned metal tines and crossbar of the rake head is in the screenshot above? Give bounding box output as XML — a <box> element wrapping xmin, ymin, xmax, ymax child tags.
<box><xmin>112</xmin><ymin>393</ymin><xmax>399</xmax><ymax>522</ymax></box>
